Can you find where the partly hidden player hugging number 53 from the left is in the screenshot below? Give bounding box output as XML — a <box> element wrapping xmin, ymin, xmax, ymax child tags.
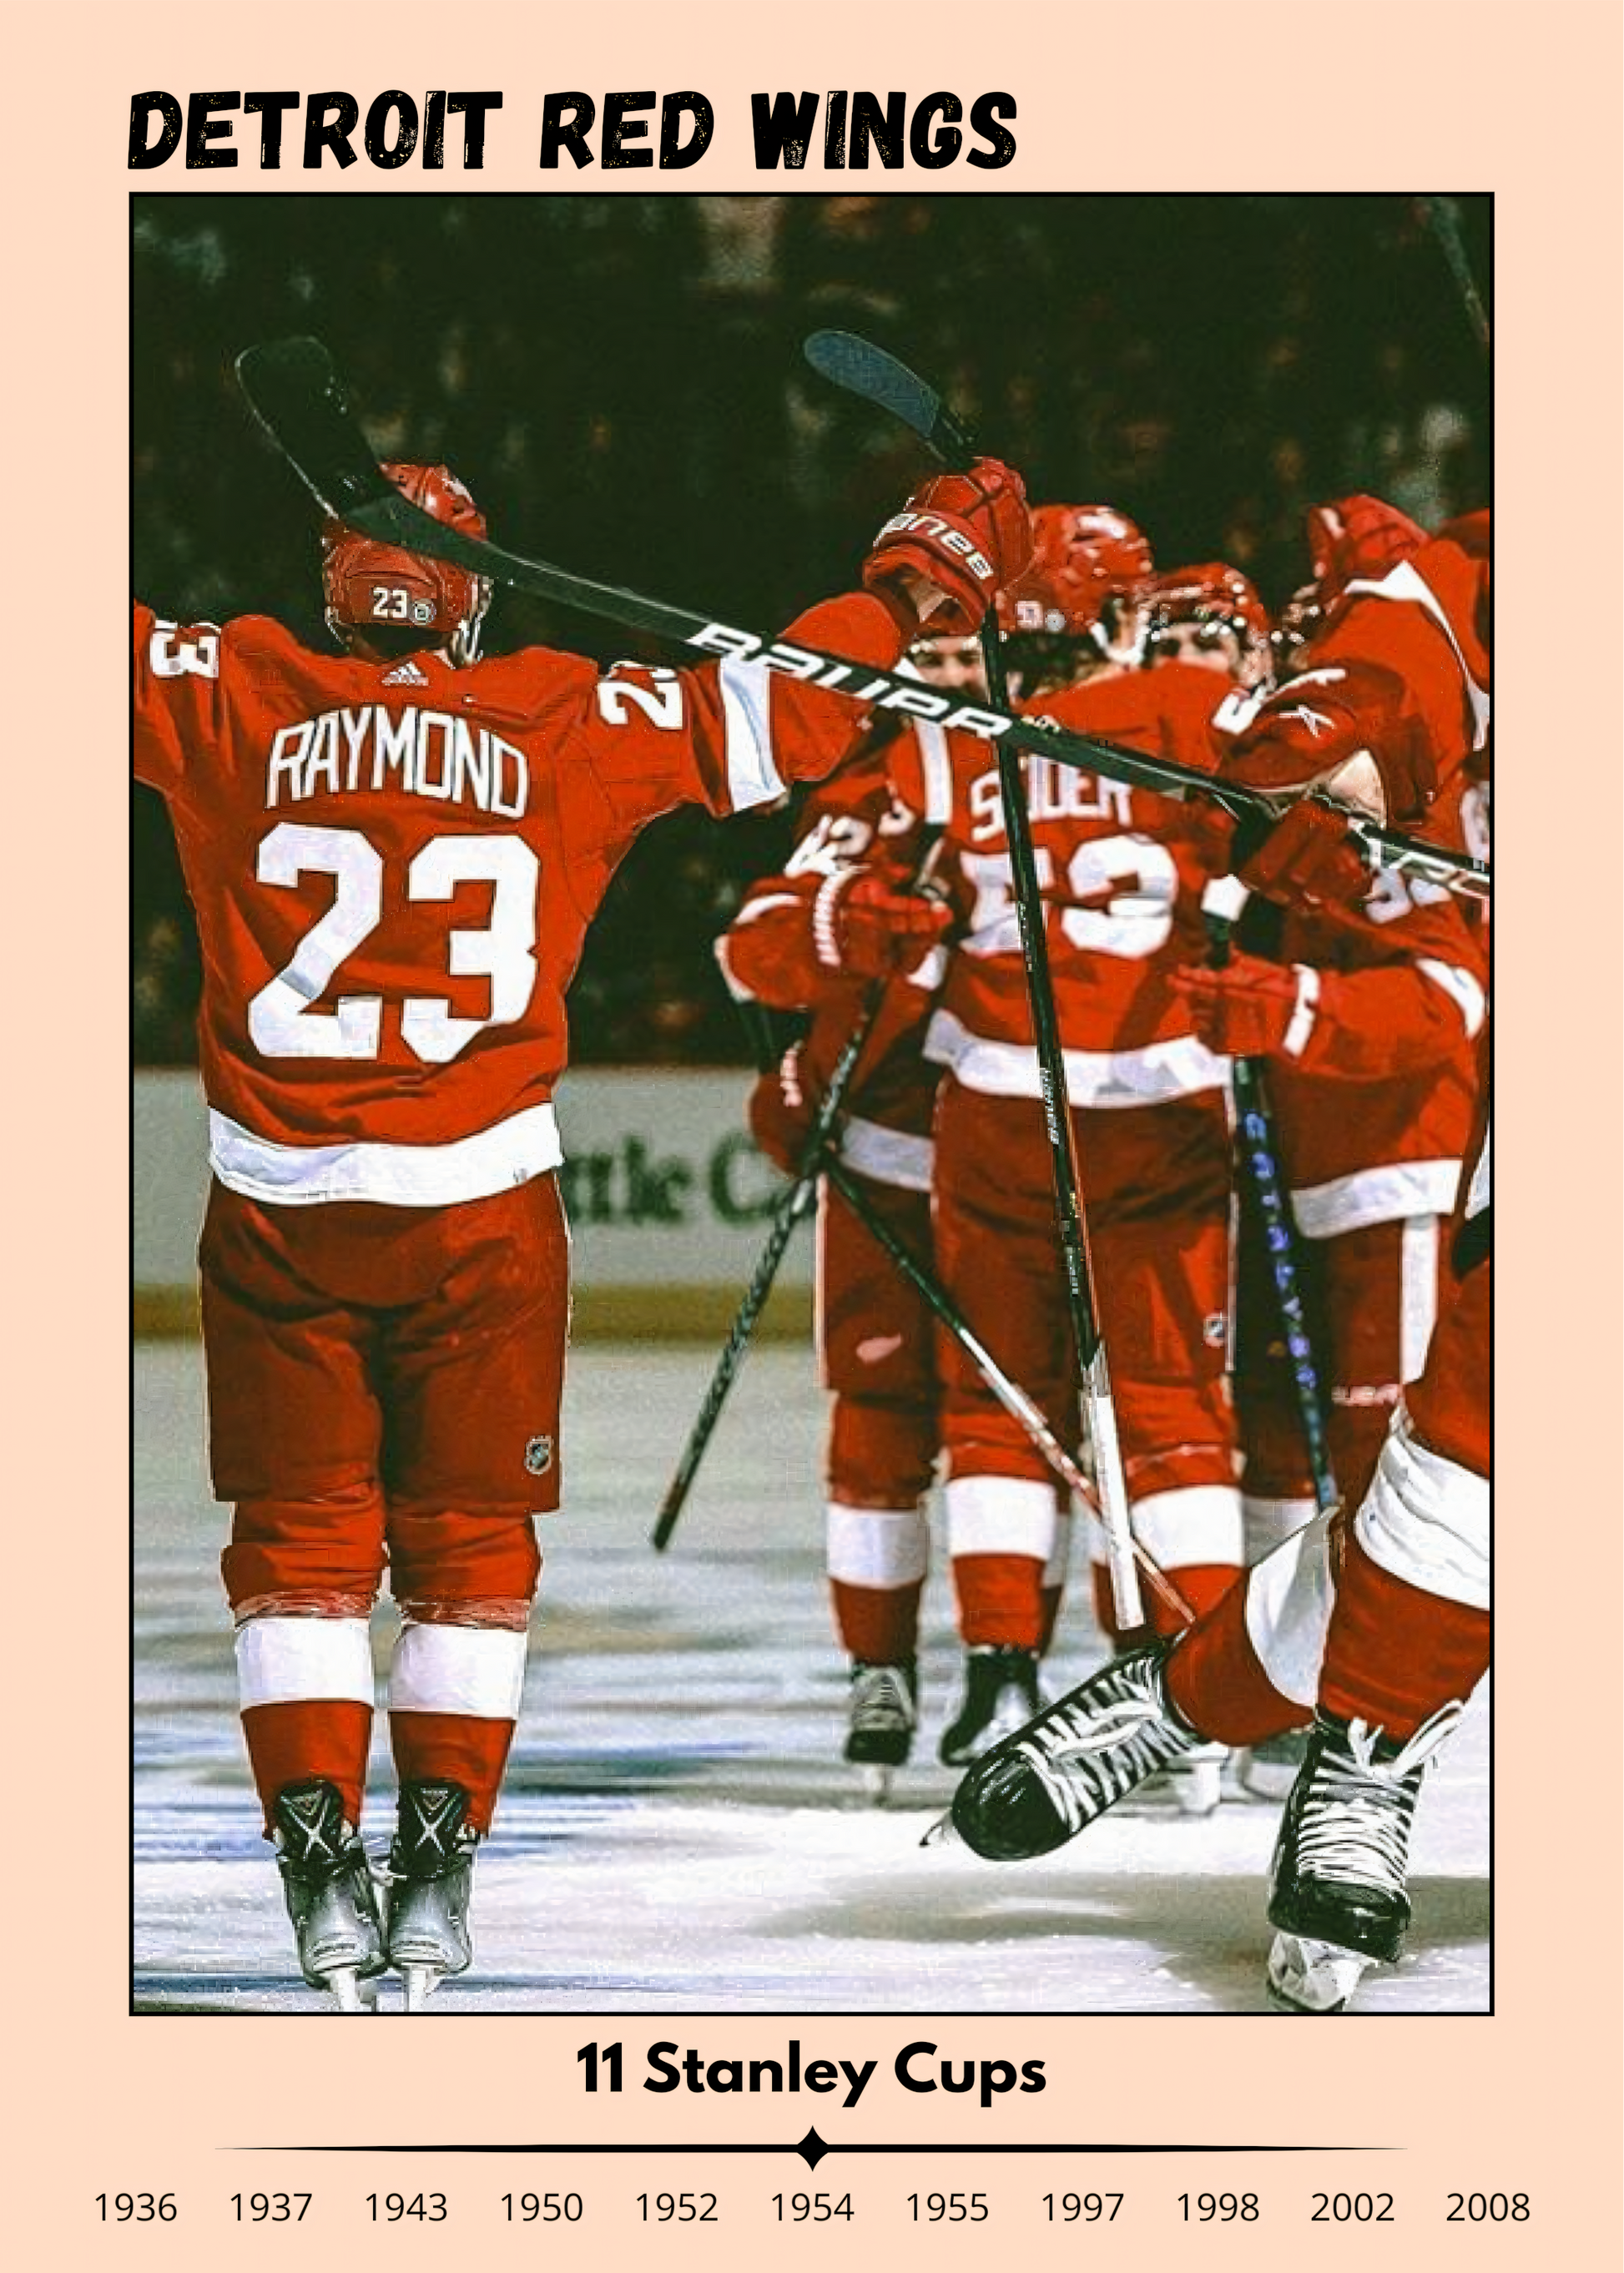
<box><xmin>719</xmin><ymin>741</ymin><xmax>949</xmax><ymax>1798</ymax></box>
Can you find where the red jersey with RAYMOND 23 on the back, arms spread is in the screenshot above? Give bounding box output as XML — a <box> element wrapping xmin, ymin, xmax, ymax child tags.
<box><xmin>134</xmin><ymin>596</ymin><xmax>900</xmax><ymax>1205</ymax></box>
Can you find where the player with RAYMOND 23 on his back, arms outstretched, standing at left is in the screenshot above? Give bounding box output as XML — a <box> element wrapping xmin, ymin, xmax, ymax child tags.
<box><xmin>134</xmin><ymin>447</ymin><xmax>1031</xmax><ymax>2009</ymax></box>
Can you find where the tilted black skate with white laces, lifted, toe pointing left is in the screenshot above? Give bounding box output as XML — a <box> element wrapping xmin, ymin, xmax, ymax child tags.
<box><xmin>949</xmin><ymin>1641</ymin><xmax>1208</xmax><ymax>1862</ymax></box>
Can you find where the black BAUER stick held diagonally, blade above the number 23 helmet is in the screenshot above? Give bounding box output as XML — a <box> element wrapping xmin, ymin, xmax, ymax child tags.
<box><xmin>236</xmin><ymin>339</ymin><xmax>1490</xmax><ymax>898</ymax></box>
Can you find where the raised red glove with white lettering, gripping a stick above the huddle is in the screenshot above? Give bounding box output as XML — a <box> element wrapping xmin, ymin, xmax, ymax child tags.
<box><xmin>862</xmin><ymin>457</ymin><xmax>1032</xmax><ymax>632</ymax></box>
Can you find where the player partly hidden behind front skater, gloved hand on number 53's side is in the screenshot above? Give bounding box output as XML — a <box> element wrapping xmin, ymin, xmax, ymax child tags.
<box><xmin>1178</xmin><ymin>498</ymin><xmax>1487</xmax><ymax>1798</ymax></box>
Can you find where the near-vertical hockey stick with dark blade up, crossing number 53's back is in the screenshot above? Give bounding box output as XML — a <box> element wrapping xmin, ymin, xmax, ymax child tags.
<box><xmin>803</xmin><ymin>332</ymin><xmax>1144</xmax><ymax>1632</ymax></box>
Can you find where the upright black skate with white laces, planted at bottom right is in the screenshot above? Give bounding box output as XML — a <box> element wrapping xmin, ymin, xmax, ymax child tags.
<box><xmin>1269</xmin><ymin>1705</ymin><xmax>1460</xmax><ymax>2012</ymax></box>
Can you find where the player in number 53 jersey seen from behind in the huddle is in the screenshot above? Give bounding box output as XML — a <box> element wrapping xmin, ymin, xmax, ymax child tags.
<box><xmin>886</xmin><ymin>536</ymin><xmax>1267</xmax><ymax>1809</ymax></box>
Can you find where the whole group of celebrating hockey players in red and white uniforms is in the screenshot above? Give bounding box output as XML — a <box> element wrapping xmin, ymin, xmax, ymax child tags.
<box><xmin>134</xmin><ymin>331</ymin><xmax>1490</xmax><ymax>2012</ymax></box>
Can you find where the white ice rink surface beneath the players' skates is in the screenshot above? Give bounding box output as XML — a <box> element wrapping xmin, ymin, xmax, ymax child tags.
<box><xmin>134</xmin><ymin>1343</ymin><xmax>1490</xmax><ymax>2013</ymax></box>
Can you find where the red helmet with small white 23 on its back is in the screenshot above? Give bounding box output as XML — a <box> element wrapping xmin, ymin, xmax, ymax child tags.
<box><xmin>320</xmin><ymin>466</ymin><xmax>492</xmax><ymax>663</ymax></box>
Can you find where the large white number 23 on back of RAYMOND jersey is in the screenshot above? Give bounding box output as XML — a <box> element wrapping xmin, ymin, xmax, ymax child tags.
<box><xmin>248</xmin><ymin>820</ymin><xmax>542</xmax><ymax>1066</ymax></box>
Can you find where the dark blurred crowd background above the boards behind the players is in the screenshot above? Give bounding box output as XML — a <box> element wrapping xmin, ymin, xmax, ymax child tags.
<box><xmin>129</xmin><ymin>194</ymin><xmax>1492</xmax><ymax>1064</ymax></box>
